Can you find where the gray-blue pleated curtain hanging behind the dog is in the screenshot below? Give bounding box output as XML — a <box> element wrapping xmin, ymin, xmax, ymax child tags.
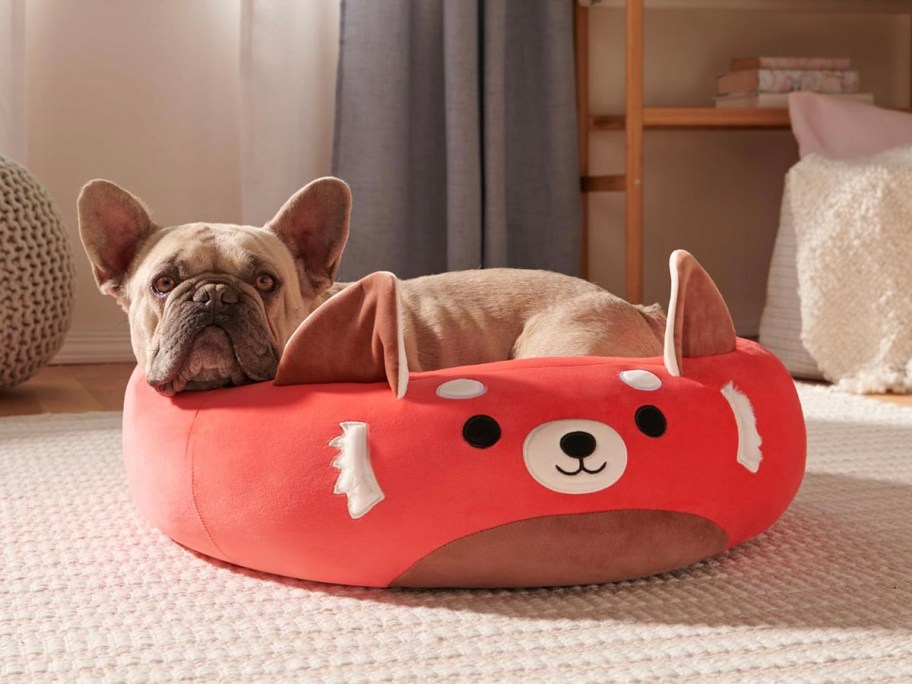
<box><xmin>333</xmin><ymin>0</ymin><xmax>581</xmax><ymax>279</ymax></box>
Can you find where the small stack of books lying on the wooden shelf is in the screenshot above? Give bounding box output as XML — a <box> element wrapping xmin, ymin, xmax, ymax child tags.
<box><xmin>715</xmin><ymin>57</ymin><xmax>874</xmax><ymax>107</ymax></box>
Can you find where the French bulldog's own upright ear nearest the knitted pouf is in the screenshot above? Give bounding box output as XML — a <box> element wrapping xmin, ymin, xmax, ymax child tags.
<box><xmin>76</xmin><ymin>179</ymin><xmax>157</xmax><ymax>299</ymax></box>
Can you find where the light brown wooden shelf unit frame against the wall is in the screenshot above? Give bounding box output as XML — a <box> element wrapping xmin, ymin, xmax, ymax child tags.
<box><xmin>572</xmin><ymin>0</ymin><xmax>912</xmax><ymax>303</ymax></box>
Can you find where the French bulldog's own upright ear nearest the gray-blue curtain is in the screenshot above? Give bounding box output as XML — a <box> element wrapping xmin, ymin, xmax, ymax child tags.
<box><xmin>266</xmin><ymin>177</ymin><xmax>351</xmax><ymax>294</ymax></box>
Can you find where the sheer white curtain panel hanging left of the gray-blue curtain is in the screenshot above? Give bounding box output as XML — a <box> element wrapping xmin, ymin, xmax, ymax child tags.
<box><xmin>241</xmin><ymin>0</ymin><xmax>340</xmax><ymax>230</ymax></box>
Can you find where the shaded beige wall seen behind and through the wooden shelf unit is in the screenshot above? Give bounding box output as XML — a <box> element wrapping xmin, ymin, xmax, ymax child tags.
<box><xmin>589</xmin><ymin>0</ymin><xmax>912</xmax><ymax>335</ymax></box>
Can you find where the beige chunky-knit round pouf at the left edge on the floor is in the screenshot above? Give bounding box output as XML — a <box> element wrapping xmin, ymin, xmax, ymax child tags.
<box><xmin>0</xmin><ymin>157</ymin><xmax>74</xmax><ymax>389</ymax></box>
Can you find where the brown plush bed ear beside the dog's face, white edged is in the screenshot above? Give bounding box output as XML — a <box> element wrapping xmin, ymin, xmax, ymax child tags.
<box><xmin>275</xmin><ymin>272</ymin><xmax>408</xmax><ymax>397</ymax></box>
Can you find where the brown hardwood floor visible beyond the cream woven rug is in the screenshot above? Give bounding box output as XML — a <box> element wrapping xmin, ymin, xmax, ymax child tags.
<box><xmin>0</xmin><ymin>363</ymin><xmax>912</xmax><ymax>417</ymax></box>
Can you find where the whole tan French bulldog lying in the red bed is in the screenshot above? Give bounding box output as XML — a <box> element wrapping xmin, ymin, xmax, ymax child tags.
<box><xmin>79</xmin><ymin>178</ymin><xmax>665</xmax><ymax>394</ymax></box>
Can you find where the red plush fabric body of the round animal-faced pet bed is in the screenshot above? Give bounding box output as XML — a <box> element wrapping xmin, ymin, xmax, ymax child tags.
<box><xmin>124</xmin><ymin>339</ymin><xmax>805</xmax><ymax>587</ymax></box>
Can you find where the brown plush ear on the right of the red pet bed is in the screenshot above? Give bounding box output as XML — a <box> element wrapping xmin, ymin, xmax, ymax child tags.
<box><xmin>665</xmin><ymin>249</ymin><xmax>736</xmax><ymax>375</ymax></box>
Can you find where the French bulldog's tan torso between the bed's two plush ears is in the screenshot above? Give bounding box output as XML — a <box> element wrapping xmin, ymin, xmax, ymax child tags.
<box><xmin>392</xmin><ymin>268</ymin><xmax>665</xmax><ymax>370</ymax></box>
